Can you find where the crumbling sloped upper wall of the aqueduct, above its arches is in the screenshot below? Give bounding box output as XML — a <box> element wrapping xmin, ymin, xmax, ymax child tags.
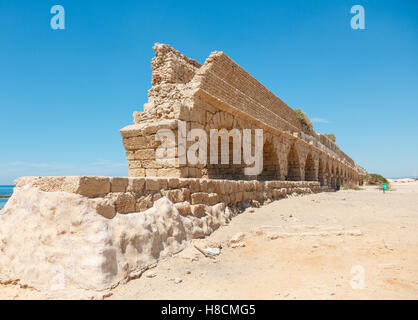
<box><xmin>134</xmin><ymin>43</ymin><xmax>354</xmax><ymax>170</ymax></box>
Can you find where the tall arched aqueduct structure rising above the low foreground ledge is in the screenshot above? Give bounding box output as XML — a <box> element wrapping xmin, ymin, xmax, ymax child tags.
<box><xmin>121</xmin><ymin>44</ymin><xmax>358</xmax><ymax>188</ymax></box>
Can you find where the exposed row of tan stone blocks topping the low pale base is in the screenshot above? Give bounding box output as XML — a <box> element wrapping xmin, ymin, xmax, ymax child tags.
<box><xmin>15</xmin><ymin>176</ymin><xmax>324</xmax><ymax>219</ymax></box>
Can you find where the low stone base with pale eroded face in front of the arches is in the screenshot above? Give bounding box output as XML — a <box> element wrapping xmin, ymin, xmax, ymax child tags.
<box><xmin>0</xmin><ymin>177</ymin><xmax>320</xmax><ymax>298</ymax></box>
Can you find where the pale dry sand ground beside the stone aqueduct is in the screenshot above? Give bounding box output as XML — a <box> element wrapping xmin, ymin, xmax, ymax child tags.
<box><xmin>0</xmin><ymin>181</ymin><xmax>418</xmax><ymax>299</ymax></box>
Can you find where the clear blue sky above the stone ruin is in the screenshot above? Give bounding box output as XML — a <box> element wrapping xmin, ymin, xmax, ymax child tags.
<box><xmin>0</xmin><ymin>0</ymin><xmax>418</xmax><ymax>184</ymax></box>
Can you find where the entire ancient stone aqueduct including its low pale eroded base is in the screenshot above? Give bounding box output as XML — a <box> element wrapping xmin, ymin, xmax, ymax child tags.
<box><xmin>0</xmin><ymin>44</ymin><xmax>358</xmax><ymax>294</ymax></box>
